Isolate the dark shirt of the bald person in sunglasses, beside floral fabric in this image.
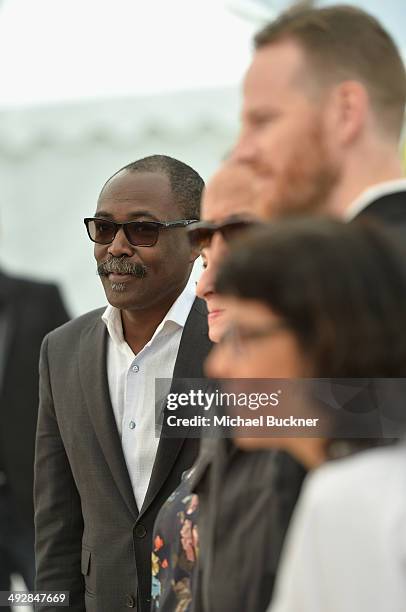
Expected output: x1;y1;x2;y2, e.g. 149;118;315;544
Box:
191;439;306;612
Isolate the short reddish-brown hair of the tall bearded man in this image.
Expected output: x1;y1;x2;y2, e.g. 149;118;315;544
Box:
254;5;406;138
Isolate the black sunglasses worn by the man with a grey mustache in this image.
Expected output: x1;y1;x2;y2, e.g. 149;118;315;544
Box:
84;217;196;247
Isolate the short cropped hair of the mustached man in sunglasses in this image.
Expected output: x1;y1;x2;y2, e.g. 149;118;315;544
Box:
102;155;204;219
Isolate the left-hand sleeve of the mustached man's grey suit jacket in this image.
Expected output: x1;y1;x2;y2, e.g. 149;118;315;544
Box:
34;336;85;612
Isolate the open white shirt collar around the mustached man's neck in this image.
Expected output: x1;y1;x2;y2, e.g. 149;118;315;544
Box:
102;277;196;347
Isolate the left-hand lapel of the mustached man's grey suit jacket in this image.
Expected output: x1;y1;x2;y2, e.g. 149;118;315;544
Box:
79;317;138;517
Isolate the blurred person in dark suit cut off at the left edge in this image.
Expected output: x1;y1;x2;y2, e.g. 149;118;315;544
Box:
0;272;68;591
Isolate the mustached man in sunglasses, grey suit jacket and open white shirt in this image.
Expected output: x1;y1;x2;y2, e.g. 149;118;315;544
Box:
35;156;210;612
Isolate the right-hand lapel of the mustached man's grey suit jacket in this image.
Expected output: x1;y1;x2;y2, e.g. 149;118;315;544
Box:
140;298;211;516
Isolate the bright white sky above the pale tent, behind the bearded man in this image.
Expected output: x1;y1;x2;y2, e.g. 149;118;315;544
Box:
0;0;406;108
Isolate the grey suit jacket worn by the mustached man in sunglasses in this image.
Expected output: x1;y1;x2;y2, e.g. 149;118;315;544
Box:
35;299;211;612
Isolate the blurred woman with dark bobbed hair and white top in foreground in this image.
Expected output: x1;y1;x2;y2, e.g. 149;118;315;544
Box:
207;219;406;612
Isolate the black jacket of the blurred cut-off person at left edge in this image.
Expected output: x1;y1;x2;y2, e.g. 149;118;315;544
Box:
0;272;69;528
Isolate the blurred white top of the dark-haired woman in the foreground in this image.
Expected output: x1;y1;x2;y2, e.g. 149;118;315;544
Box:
268;444;406;612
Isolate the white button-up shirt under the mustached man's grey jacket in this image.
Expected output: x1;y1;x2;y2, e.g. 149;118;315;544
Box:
102;280;196;510
